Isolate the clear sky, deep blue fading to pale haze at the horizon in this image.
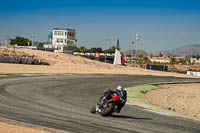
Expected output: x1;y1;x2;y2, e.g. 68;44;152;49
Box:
0;0;200;52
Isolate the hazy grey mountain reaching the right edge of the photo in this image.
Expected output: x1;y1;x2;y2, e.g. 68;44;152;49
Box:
154;44;200;56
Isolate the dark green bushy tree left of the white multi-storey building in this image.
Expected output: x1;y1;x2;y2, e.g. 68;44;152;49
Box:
10;37;30;46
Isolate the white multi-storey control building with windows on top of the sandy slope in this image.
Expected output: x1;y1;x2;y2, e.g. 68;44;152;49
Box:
44;28;77;52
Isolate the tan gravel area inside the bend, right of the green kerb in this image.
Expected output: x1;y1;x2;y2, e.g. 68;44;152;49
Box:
145;83;200;118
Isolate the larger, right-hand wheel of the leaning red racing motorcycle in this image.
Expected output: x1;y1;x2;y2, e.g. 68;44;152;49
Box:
101;102;116;116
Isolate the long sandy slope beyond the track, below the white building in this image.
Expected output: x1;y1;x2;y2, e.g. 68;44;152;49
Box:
0;46;198;77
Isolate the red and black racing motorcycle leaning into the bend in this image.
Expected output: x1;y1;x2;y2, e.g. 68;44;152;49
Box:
91;92;122;116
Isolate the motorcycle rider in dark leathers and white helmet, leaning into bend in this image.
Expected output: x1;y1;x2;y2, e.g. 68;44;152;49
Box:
98;85;127;113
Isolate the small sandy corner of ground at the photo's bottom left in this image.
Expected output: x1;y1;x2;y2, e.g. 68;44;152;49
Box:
0;122;52;133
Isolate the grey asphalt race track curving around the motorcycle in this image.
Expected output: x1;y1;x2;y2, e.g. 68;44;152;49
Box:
0;74;200;133
